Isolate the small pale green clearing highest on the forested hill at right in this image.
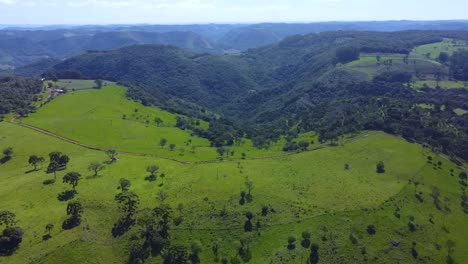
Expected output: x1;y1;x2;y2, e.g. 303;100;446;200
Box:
411;39;468;60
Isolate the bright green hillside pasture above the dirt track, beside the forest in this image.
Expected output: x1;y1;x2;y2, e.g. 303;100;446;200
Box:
21;85;320;161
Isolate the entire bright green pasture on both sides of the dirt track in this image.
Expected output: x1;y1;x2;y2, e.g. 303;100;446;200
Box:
0;81;468;263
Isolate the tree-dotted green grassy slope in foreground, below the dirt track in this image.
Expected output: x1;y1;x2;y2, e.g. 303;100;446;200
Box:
0;118;468;263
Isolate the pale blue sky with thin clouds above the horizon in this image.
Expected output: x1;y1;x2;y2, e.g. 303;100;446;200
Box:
0;0;468;24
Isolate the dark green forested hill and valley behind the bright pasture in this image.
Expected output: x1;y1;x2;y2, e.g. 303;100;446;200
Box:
48;31;468;159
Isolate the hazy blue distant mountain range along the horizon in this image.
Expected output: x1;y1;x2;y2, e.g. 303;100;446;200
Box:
0;20;468;72
